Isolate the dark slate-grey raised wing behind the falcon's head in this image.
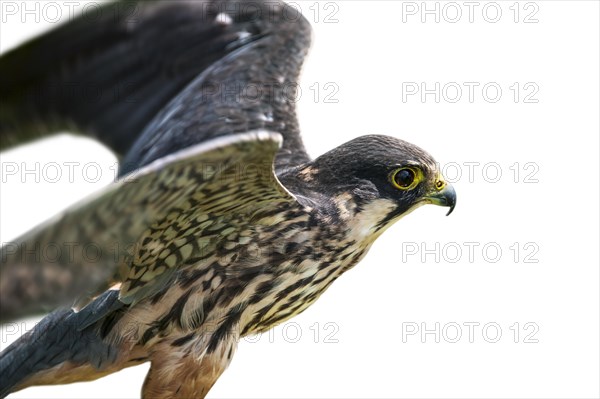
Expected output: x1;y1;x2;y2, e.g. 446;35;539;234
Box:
0;0;310;170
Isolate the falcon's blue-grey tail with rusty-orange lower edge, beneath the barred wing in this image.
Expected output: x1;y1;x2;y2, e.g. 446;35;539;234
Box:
0;309;118;398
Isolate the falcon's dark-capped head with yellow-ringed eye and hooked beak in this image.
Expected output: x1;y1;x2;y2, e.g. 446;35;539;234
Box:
290;135;456;241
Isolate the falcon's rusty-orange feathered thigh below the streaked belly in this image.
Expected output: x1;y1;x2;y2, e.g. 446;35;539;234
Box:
142;329;239;399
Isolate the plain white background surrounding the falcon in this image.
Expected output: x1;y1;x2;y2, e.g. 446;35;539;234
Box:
0;1;600;398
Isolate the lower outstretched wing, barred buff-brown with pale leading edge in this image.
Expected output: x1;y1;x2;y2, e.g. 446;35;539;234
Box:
0;131;295;324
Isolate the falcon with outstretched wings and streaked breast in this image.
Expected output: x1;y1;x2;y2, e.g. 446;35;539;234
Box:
0;0;456;398
